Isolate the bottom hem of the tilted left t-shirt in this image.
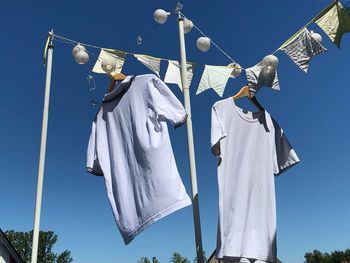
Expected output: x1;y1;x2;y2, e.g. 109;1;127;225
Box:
124;197;191;245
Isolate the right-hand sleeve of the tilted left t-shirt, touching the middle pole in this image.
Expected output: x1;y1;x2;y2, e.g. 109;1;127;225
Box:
151;78;187;128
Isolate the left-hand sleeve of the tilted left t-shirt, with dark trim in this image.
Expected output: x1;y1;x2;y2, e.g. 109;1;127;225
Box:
86;119;103;176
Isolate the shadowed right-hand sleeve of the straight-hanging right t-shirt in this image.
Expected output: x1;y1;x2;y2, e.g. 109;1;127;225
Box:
272;119;300;175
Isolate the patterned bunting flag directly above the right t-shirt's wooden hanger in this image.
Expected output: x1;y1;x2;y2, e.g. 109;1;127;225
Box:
245;62;280;91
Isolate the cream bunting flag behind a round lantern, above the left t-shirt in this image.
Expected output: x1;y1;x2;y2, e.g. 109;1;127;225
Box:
92;49;127;75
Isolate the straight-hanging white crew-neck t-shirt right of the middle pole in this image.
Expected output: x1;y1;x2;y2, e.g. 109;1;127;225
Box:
211;98;299;263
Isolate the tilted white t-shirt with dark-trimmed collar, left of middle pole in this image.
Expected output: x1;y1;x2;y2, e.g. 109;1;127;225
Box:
87;74;191;244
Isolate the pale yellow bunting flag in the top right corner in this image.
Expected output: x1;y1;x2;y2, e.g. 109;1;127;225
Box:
314;1;350;48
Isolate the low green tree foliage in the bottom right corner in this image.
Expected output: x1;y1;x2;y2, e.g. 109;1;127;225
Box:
304;249;350;263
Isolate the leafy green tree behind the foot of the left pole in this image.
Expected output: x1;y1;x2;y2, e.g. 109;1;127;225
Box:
5;230;73;263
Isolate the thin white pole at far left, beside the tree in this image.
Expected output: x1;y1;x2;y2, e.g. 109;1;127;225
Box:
31;30;53;263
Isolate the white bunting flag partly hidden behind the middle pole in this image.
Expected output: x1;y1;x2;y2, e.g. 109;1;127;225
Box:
164;60;196;90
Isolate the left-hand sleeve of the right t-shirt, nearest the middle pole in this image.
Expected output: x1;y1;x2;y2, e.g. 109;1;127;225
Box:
210;105;227;156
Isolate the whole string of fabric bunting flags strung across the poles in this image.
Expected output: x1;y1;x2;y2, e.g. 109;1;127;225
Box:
45;0;350;97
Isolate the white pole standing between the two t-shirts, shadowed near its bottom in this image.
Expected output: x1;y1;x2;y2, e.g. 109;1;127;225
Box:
177;13;203;263
